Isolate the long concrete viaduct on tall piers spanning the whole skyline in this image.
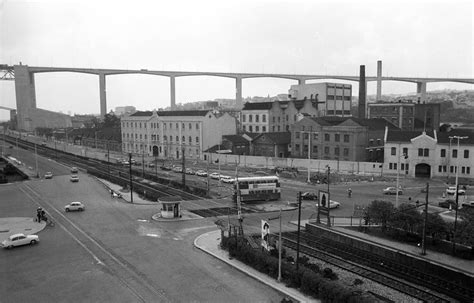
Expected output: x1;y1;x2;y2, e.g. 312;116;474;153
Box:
0;61;474;131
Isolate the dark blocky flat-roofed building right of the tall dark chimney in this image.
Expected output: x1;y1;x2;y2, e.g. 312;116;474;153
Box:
367;102;440;131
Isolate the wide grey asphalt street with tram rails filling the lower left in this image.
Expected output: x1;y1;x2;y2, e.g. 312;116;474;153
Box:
0;144;283;302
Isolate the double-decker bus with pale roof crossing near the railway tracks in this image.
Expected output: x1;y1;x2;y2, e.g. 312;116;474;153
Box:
234;176;281;202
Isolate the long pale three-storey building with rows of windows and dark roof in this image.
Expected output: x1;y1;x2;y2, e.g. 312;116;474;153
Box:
121;110;237;159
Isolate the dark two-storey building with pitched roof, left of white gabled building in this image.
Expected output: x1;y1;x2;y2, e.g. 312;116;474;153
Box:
291;117;396;162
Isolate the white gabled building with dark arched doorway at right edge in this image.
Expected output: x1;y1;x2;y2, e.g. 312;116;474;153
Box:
384;130;474;179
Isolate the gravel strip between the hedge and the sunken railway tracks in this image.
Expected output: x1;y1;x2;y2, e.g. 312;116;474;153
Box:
286;248;423;303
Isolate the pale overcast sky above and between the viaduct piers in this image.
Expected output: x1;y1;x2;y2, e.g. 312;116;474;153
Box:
0;0;474;120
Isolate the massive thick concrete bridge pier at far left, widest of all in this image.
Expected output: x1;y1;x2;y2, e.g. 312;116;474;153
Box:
14;65;36;130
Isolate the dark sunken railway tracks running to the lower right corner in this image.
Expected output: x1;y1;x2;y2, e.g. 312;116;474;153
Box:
284;232;474;302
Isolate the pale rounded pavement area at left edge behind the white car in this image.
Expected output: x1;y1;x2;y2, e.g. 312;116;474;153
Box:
0;217;46;242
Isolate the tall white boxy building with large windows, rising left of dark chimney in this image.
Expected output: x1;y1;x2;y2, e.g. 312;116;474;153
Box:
288;82;352;117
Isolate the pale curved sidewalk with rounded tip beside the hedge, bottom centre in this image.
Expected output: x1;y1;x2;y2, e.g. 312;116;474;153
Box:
194;230;321;302
